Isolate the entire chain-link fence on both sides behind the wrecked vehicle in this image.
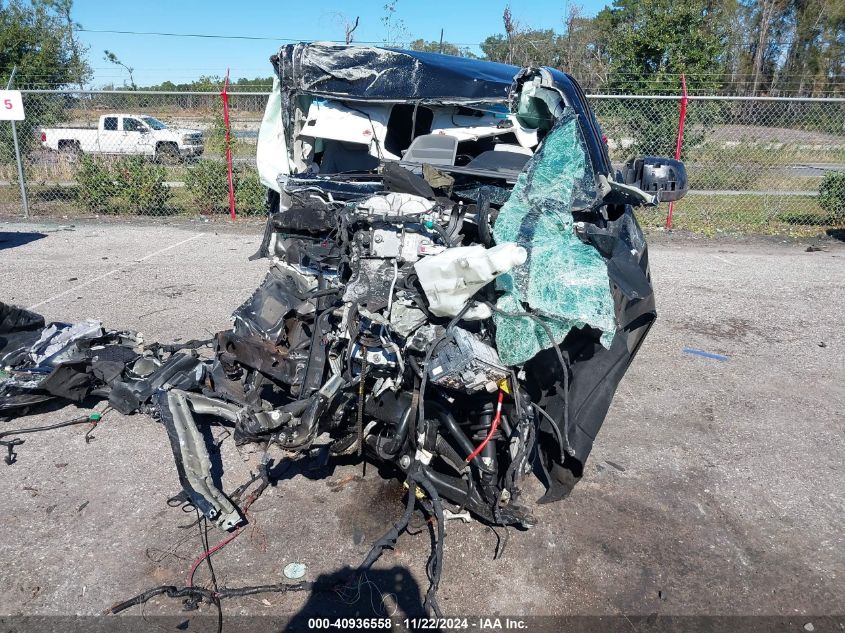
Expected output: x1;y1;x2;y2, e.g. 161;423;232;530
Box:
0;90;845;233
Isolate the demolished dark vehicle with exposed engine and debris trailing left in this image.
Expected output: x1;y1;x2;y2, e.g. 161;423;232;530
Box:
0;44;686;612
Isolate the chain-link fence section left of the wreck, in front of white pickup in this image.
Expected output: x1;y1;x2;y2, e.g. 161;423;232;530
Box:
0;90;267;216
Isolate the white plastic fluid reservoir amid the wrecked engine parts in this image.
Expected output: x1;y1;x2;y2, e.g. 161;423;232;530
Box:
414;242;528;318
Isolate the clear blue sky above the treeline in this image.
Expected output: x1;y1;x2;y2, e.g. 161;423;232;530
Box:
73;0;606;86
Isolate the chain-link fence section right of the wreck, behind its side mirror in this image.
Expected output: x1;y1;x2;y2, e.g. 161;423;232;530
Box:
591;95;845;233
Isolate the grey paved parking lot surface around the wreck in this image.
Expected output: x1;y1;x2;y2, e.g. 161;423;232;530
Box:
0;216;845;631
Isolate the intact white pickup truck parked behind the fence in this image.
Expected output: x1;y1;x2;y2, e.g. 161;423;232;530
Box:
41;114;203;163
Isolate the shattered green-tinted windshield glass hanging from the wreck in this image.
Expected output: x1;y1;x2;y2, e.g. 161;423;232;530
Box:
493;115;616;365
